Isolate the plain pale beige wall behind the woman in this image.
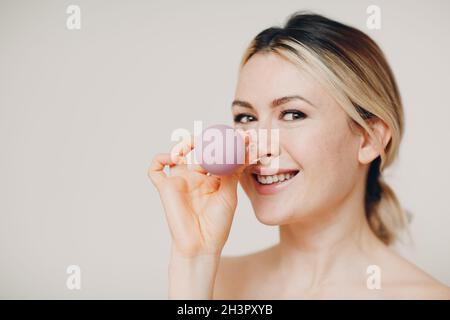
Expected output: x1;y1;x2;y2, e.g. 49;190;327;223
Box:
0;0;450;299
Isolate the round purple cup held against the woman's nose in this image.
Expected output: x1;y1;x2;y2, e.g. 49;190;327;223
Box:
195;124;245;176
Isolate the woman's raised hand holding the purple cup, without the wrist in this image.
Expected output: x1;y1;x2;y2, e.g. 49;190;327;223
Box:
148;136;249;258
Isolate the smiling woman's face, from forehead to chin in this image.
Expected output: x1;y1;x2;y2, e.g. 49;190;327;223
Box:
232;53;361;225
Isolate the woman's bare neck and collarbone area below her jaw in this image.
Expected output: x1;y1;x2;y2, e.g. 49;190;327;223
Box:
277;181;385;290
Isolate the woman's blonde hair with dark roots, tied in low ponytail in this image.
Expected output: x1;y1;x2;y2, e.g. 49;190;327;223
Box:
240;12;407;245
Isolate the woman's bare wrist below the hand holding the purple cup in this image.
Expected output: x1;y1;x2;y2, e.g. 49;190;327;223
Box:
169;246;220;299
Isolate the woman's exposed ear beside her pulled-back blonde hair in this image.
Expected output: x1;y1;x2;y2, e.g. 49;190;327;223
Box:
358;118;392;164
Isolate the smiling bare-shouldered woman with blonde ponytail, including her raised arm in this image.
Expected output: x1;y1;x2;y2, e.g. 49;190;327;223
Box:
149;13;450;299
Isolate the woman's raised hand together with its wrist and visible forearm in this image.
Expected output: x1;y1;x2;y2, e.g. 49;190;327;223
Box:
148;136;249;299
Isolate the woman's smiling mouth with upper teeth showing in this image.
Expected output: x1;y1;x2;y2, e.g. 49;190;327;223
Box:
251;170;300;195
